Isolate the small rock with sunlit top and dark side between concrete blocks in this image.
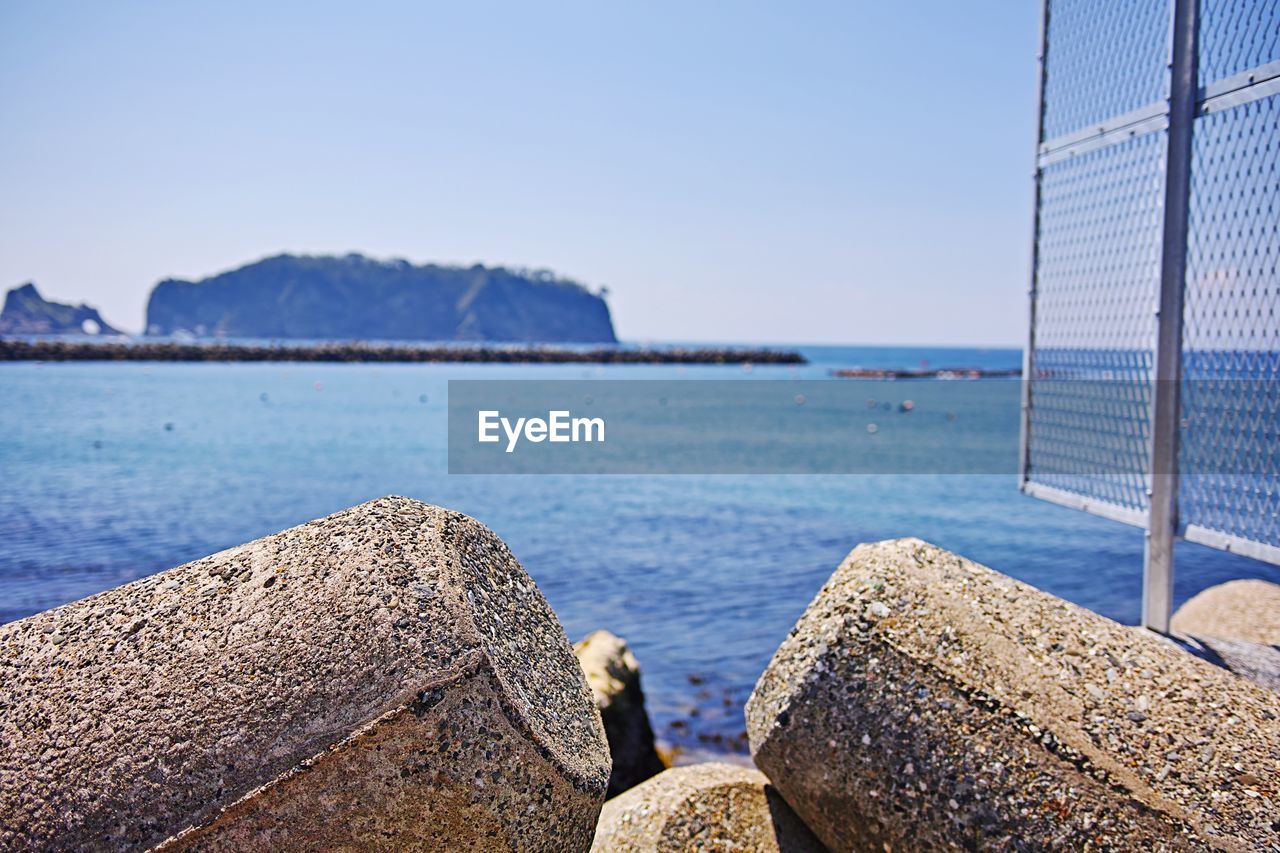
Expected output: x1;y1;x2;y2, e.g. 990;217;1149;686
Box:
573;630;664;797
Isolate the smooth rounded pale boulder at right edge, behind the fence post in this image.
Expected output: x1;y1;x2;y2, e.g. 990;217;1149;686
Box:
1171;580;1280;646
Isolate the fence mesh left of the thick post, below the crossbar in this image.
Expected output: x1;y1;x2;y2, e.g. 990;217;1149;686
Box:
1029;133;1165;510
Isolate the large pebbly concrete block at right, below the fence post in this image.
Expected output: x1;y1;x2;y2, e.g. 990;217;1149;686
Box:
746;539;1280;850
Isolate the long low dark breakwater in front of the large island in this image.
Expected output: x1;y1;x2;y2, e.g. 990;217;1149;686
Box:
0;339;806;365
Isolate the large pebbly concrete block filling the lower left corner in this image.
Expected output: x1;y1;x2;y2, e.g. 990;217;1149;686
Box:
0;497;609;850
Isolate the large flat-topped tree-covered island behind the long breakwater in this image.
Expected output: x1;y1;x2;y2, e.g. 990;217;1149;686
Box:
147;255;617;343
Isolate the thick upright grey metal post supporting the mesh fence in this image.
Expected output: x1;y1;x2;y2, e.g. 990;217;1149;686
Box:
1142;0;1199;634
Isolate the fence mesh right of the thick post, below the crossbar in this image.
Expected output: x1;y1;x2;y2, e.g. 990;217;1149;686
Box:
1179;95;1280;544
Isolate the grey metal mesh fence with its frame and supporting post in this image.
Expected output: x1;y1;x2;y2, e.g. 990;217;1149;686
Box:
1023;0;1280;629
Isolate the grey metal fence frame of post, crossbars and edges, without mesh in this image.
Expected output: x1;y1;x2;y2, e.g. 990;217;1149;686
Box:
1019;0;1280;633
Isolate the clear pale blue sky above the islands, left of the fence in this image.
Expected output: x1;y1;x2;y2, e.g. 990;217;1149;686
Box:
0;0;1037;343
